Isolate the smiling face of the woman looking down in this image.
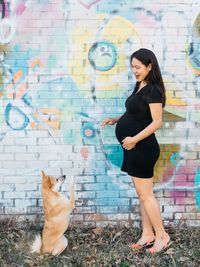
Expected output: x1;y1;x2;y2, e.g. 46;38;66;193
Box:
131;58;151;82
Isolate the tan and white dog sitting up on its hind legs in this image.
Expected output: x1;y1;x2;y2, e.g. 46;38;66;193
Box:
31;171;75;255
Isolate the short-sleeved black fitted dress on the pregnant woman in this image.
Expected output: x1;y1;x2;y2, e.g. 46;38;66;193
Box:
115;84;162;178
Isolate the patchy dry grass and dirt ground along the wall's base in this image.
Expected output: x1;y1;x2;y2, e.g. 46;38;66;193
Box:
0;220;200;267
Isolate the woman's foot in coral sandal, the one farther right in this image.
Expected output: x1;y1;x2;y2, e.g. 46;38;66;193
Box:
147;233;172;254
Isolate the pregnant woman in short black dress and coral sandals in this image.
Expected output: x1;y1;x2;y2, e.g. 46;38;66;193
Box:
101;48;171;254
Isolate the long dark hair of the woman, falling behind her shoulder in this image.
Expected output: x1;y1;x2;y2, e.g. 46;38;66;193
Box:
130;48;166;107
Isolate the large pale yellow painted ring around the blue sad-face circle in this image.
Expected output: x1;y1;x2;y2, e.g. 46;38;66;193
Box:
67;15;141;96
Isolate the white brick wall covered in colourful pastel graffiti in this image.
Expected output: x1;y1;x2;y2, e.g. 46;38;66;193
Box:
0;0;200;225
